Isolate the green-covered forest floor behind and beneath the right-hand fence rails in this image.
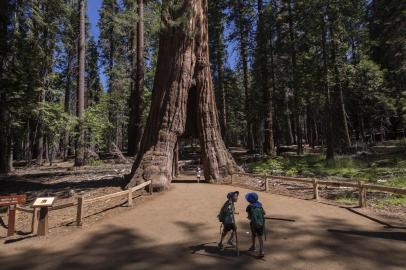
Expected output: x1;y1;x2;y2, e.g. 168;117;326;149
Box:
248;141;406;208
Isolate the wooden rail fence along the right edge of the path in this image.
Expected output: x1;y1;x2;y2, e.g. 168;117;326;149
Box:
231;173;406;207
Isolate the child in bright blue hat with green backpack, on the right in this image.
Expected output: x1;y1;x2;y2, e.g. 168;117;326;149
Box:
245;192;265;258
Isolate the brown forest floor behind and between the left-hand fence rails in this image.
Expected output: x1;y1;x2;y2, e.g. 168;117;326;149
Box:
0;162;136;240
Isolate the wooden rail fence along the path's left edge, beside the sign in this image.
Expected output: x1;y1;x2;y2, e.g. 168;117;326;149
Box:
17;181;152;234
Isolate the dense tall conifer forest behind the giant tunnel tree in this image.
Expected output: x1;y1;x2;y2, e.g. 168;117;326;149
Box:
0;0;406;173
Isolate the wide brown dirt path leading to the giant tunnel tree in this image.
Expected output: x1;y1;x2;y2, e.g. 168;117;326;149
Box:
0;183;406;270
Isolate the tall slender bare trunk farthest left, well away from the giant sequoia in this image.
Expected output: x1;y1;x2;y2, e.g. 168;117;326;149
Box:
75;0;85;166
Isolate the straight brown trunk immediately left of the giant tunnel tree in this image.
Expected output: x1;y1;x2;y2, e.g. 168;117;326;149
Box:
128;0;144;156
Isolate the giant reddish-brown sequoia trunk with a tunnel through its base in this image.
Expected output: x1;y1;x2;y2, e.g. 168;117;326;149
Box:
128;0;239;189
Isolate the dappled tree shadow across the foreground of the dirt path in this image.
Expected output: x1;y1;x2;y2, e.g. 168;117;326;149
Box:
0;214;406;270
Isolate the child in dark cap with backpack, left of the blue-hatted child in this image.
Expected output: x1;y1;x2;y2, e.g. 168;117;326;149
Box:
217;191;240;250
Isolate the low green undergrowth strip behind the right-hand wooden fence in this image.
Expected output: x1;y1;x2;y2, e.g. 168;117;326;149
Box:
250;150;406;187
